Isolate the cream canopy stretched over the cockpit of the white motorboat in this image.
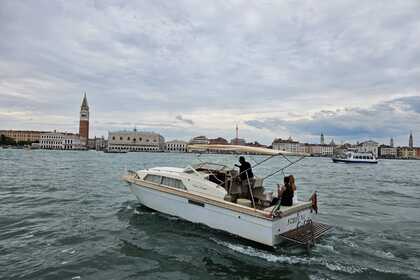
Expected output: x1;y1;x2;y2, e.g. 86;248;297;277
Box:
188;144;310;157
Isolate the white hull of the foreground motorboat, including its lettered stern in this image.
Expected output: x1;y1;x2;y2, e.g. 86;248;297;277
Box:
130;180;313;246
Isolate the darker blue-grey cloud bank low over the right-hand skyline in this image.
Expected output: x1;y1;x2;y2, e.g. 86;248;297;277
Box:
246;96;420;139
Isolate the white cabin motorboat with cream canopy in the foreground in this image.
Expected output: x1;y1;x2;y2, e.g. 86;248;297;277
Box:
123;145;330;248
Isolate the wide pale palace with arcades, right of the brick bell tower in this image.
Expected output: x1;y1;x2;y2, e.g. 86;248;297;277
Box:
107;129;165;152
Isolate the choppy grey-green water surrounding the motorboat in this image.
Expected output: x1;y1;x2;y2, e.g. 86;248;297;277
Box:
0;149;420;279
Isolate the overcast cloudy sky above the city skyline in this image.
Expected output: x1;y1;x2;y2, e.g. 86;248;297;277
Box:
0;0;420;145
